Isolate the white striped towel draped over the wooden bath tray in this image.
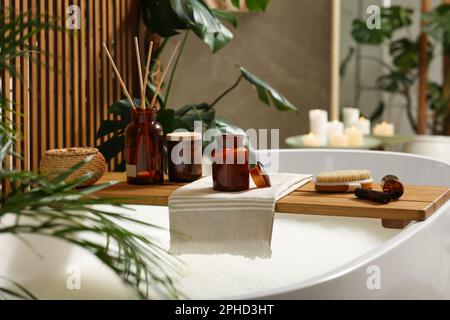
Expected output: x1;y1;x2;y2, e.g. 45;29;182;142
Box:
169;173;312;257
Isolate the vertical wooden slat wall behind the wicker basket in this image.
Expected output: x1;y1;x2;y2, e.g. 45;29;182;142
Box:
0;0;140;171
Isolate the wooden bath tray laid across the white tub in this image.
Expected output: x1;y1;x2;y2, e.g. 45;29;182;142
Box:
96;173;450;229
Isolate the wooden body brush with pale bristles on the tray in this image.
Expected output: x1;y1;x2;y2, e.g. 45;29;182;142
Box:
315;170;374;192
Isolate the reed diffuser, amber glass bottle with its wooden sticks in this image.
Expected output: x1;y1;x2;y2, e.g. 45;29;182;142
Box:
103;37;179;185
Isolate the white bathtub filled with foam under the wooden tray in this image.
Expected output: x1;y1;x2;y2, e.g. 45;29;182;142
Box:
0;150;450;299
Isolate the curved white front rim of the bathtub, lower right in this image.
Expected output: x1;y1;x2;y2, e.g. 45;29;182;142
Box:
232;201;450;300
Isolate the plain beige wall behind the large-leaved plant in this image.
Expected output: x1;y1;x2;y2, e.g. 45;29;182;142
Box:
167;0;330;146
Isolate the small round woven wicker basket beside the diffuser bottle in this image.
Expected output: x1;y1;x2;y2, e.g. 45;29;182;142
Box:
40;148;106;187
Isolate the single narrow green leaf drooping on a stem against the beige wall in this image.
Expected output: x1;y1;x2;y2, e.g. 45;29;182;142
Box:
240;67;298;111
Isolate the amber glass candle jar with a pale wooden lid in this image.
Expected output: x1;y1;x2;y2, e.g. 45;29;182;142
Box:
166;132;203;182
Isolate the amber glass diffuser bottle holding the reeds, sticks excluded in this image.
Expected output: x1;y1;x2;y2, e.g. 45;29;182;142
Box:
125;109;164;185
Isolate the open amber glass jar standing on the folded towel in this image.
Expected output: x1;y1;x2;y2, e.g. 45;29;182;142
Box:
212;134;250;192
